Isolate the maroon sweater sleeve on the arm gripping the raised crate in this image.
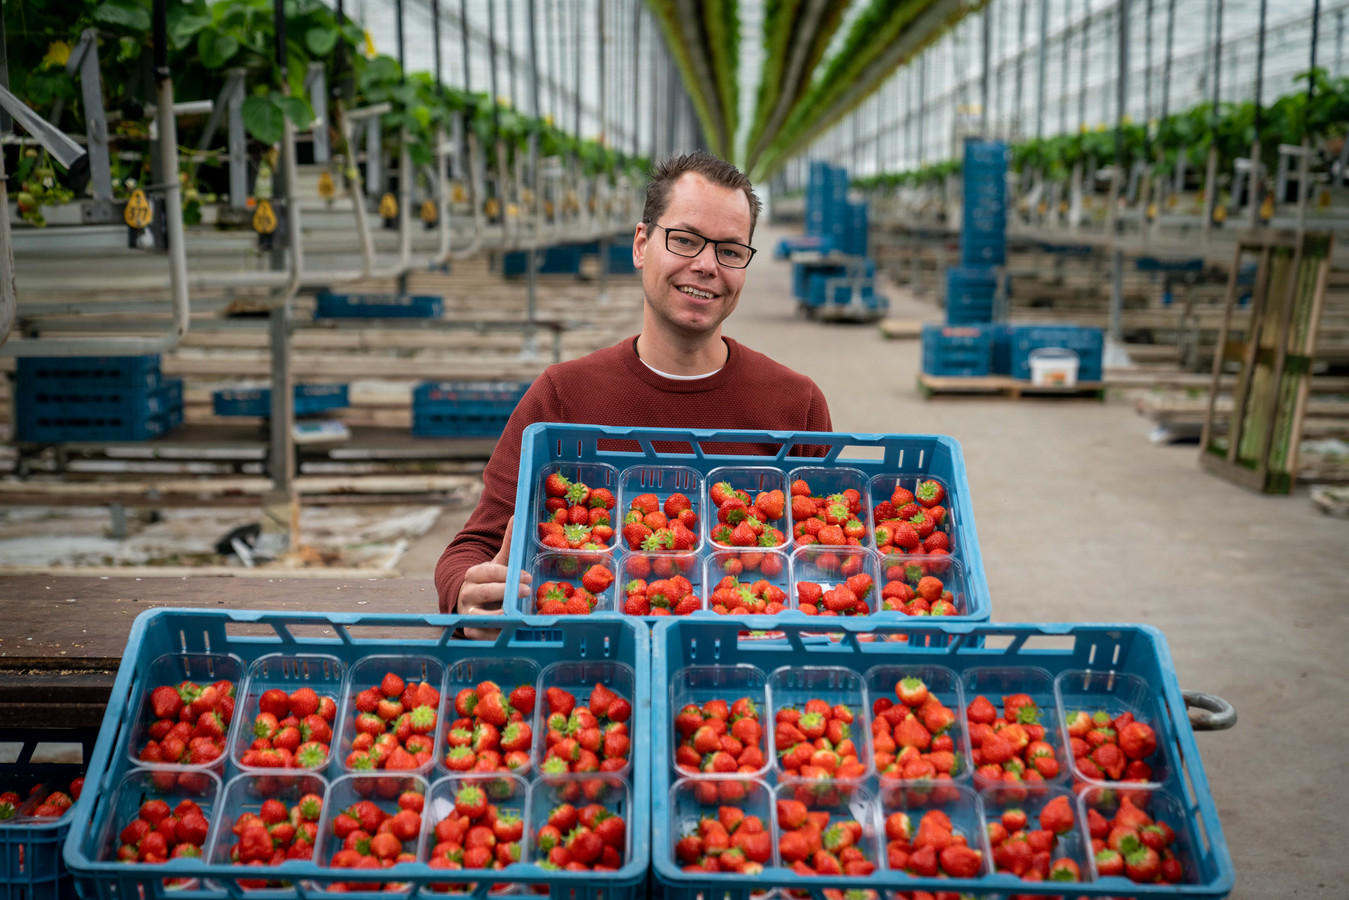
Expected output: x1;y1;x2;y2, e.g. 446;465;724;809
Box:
436;372;563;613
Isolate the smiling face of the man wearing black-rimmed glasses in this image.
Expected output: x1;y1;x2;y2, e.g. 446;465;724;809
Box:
633;173;750;341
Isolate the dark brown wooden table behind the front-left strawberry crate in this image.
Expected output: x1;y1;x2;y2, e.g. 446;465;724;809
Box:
0;576;438;727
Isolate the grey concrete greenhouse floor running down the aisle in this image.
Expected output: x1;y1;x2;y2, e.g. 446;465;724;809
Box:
399;228;1349;900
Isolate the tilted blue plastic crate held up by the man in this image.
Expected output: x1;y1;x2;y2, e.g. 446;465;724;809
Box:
506;422;992;621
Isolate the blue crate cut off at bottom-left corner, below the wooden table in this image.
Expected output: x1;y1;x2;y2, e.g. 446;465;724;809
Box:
0;729;98;900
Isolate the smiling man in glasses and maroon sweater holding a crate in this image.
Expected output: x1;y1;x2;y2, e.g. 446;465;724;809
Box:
436;151;832;614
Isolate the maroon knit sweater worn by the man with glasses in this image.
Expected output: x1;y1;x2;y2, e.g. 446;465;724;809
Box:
436;337;832;613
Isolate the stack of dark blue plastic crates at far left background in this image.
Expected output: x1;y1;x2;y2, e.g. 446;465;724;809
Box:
15;355;182;444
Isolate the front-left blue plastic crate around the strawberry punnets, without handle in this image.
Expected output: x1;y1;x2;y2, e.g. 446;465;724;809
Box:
63;609;652;900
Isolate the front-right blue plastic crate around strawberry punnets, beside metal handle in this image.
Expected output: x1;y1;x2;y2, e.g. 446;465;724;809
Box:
652;618;1234;900
